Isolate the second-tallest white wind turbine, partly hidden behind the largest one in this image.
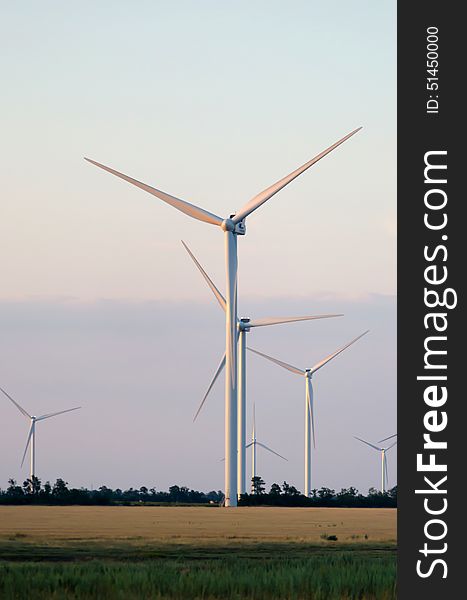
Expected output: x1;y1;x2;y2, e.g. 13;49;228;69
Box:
182;240;342;497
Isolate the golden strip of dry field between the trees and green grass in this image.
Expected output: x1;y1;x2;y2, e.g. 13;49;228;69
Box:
0;506;396;544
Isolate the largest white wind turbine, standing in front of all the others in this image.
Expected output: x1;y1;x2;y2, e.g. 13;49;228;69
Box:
85;127;361;506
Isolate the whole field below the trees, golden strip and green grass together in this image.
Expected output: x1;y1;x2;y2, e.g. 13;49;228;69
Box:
0;506;396;600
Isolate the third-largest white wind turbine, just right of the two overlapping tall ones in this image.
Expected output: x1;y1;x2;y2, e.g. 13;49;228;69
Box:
248;331;368;496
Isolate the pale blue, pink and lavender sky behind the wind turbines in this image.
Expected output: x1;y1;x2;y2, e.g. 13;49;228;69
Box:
0;0;396;490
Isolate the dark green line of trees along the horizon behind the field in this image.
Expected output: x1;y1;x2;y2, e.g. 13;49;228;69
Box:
0;477;397;508
